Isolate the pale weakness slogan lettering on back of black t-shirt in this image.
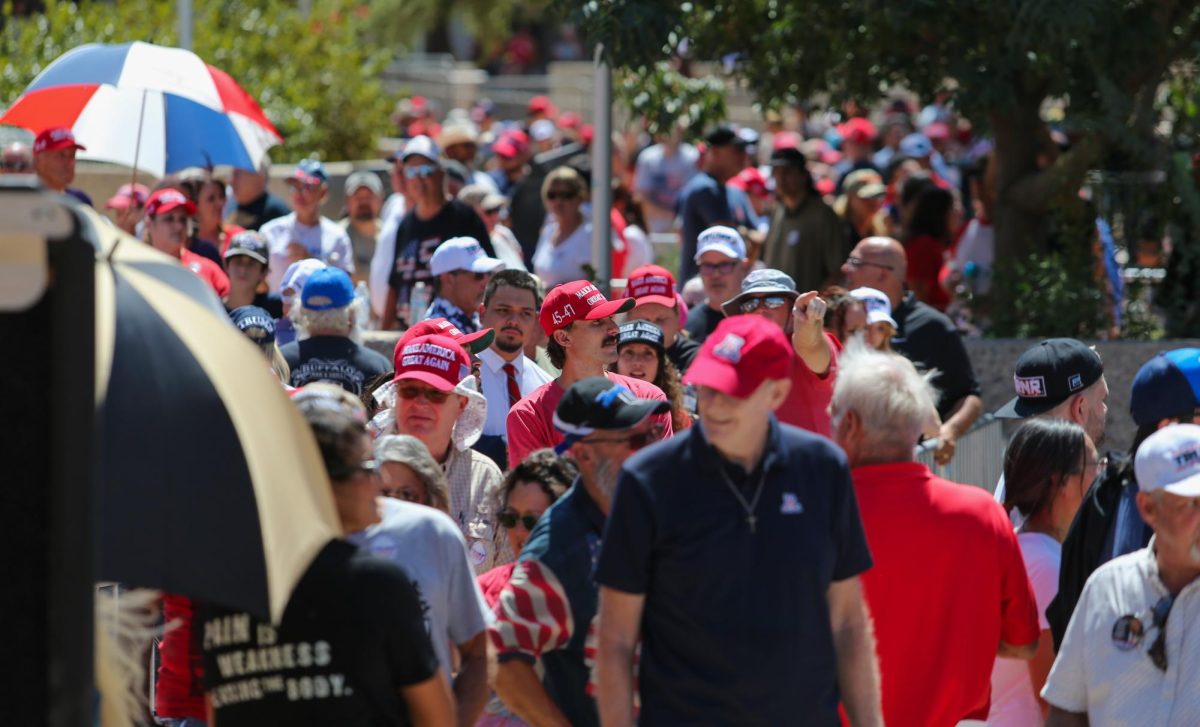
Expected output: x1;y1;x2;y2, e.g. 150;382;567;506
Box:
204;613;354;709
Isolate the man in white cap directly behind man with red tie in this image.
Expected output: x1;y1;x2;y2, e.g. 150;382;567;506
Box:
421;238;504;334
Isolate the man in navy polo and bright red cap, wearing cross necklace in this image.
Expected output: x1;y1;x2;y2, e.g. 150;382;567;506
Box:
596;316;882;726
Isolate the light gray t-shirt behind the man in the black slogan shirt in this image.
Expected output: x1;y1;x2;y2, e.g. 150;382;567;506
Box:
347;498;492;678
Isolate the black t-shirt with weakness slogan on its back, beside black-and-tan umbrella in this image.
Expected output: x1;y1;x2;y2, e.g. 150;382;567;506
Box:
196;540;438;727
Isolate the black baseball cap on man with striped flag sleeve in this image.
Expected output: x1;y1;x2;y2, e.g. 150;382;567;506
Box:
554;377;671;455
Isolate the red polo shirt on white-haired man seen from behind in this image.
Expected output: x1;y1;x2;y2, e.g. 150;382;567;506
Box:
851;462;1039;727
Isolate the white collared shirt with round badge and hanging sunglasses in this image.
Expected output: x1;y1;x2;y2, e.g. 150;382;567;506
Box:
1042;539;1200;727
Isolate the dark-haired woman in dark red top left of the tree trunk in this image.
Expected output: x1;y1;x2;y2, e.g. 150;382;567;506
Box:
901;185;961;311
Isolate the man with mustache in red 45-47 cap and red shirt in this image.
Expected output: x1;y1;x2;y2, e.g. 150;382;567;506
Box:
508;281;674;465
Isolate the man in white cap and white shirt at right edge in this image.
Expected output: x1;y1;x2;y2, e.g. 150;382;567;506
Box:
1042;423;1200;727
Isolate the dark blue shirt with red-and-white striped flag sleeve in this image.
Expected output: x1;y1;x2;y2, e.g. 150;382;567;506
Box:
488;477;605;727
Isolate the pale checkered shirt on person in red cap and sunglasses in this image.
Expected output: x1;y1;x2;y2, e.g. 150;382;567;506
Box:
442;444;515;576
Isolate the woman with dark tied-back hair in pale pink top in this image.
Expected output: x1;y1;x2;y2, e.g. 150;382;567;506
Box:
988;417;1098;727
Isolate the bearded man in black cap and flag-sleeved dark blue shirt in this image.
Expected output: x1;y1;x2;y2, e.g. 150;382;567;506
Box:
488;377;671;727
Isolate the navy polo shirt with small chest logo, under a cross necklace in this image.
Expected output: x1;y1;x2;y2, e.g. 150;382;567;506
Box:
596;416;871;726
